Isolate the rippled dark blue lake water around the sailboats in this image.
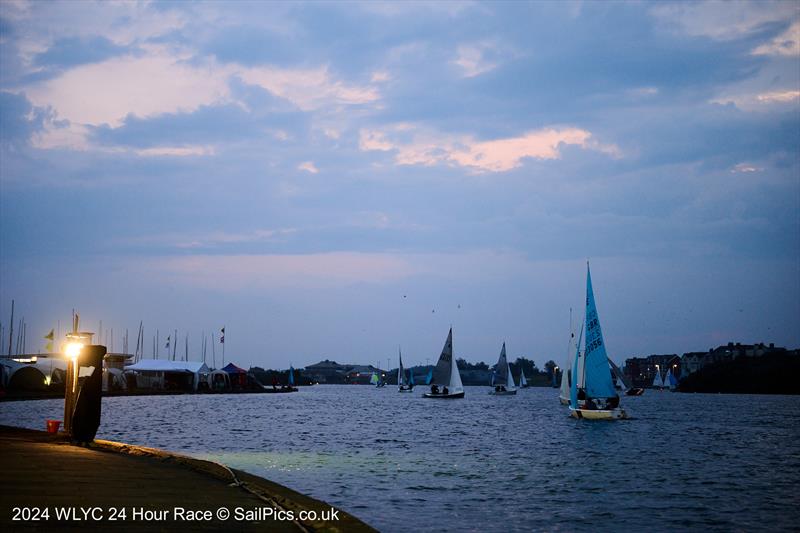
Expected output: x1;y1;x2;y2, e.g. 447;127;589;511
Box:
0;386;800;532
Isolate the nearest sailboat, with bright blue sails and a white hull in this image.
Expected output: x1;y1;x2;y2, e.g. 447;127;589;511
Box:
569;262;628;420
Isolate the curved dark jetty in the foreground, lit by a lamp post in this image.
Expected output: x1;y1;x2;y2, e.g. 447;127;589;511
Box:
0;426;375;532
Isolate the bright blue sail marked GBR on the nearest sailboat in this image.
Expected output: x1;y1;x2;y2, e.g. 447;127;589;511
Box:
584;263;617;398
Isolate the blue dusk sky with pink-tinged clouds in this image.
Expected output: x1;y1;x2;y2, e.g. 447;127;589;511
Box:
0;0;800;368
